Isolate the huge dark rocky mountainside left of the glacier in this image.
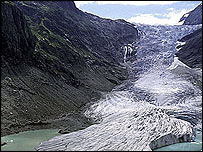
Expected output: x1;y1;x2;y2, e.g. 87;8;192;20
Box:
1;1;138;136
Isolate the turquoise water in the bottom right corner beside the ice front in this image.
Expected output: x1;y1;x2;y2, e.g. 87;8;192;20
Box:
154;132;202;151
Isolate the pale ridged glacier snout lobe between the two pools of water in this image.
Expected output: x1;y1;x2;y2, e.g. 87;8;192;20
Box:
36;102;193;151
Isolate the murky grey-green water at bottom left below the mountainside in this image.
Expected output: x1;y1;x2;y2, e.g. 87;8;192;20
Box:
1;129;61;151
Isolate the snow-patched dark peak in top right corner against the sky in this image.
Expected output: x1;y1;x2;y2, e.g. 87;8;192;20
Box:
179;3;202;25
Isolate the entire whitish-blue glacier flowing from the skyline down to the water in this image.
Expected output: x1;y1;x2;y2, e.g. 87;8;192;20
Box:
36;25;202;151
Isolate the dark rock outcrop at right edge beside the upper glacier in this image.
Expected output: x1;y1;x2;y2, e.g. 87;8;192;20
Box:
176;28;202;68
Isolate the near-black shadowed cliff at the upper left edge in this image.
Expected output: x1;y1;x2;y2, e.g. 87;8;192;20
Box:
1;2;36;65
